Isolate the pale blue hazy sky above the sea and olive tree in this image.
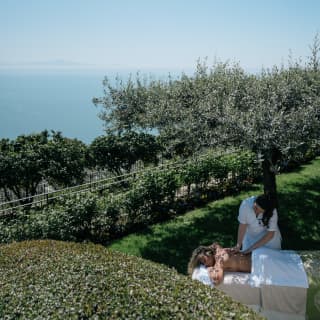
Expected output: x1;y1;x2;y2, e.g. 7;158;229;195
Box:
0;0;320;70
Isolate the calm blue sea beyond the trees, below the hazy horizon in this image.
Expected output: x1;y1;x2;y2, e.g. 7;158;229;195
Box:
0;68;182;144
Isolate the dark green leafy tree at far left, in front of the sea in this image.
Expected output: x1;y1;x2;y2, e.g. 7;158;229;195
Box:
0;131;86;203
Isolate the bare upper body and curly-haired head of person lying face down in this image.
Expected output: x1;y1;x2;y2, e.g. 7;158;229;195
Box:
188;243;251;285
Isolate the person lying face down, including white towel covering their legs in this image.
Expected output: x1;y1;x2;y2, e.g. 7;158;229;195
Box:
188;243;309;288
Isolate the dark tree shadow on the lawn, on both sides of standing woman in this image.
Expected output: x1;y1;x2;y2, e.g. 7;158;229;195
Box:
140;172;320;274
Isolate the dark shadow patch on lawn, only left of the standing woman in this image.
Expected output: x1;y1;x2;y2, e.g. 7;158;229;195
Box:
140;201;239;273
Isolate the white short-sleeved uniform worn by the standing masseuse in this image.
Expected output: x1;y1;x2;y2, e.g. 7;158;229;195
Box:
238;196;281;250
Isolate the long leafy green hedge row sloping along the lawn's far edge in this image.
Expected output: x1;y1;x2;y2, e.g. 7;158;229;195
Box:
0;152;258;243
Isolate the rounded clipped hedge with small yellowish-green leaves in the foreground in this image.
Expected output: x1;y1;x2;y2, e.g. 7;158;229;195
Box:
0;241;260;320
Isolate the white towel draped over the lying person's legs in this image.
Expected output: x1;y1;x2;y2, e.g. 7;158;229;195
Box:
249;248;309;288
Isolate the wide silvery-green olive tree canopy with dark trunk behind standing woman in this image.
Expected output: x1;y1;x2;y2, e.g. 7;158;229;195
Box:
95;43;320;206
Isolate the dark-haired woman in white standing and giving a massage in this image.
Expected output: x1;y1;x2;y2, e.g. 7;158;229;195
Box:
233;195;281;254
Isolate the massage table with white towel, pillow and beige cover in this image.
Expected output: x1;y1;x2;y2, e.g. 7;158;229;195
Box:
192;248;308;320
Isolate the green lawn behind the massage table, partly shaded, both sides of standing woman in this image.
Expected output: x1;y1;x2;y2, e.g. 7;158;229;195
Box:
109;158;320;273
